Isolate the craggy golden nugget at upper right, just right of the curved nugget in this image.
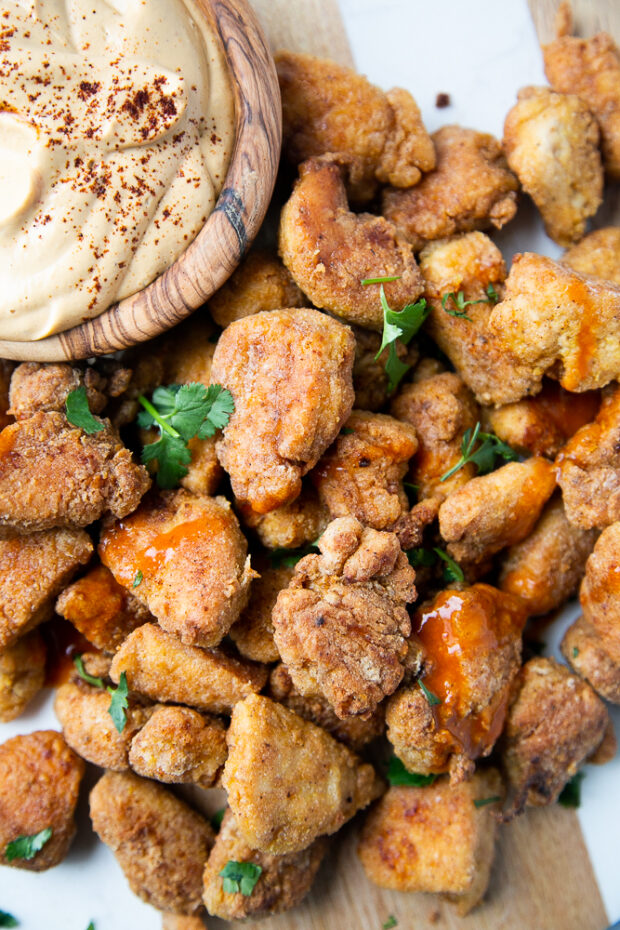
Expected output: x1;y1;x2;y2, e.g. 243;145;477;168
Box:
382;126;519;252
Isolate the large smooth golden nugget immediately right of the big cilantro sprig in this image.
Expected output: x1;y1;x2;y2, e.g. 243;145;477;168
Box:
211;310;355;513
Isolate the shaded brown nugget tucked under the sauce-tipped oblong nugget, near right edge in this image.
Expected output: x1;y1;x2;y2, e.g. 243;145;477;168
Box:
499;497;596;617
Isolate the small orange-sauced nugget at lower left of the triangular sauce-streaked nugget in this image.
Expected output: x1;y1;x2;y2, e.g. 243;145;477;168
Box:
55;565;153;652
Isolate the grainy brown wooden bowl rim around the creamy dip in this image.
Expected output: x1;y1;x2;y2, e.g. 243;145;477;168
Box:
0;0;282;362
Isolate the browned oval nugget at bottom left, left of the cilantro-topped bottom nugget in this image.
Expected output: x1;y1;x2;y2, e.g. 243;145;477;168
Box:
90;772;214;915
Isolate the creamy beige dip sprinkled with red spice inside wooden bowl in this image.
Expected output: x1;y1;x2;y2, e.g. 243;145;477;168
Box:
0;0;234;340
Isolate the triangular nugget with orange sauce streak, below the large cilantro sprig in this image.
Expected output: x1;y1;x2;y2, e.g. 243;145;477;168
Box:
99;490;256;647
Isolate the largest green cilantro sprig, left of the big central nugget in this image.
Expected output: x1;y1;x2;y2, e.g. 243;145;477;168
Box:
138;382;235;488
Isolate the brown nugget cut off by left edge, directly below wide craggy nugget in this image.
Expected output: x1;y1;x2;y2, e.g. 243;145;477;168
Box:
0;529;93;649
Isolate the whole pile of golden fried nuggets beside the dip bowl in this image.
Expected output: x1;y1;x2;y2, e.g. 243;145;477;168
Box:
0;11;620;930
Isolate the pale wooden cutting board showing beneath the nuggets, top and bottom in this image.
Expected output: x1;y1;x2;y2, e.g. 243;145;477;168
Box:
209;0;620;930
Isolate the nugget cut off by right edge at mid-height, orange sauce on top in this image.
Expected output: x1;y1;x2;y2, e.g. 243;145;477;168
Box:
556;385;620;529
